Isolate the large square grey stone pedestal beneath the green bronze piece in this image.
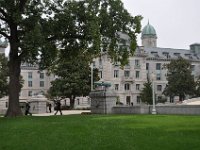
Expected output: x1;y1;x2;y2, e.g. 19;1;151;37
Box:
90;90;117;114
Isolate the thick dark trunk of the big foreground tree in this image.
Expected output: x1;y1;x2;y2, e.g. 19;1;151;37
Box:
5;26;22;117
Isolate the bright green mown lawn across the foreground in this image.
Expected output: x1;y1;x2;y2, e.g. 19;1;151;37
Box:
0;115;200;150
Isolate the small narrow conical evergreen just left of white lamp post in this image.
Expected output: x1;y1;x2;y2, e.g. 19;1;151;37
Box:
140;79;153;105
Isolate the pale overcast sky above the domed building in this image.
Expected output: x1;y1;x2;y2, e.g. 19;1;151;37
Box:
122;0;200;49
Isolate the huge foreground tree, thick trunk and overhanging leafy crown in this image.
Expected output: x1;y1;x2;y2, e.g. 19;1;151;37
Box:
0;0;141;116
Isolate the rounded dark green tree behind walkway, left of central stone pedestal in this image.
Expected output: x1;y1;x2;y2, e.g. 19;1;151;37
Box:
49;55;99;108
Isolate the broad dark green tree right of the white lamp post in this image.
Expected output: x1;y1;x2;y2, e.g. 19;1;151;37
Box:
163;58;195;101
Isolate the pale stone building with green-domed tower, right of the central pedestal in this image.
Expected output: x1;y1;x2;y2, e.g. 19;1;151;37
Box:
94;22;200;105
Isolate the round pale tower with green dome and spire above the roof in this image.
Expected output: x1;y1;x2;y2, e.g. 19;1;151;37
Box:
141;21;157;47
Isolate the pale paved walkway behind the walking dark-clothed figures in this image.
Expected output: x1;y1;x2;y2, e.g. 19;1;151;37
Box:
33;110;91;116
